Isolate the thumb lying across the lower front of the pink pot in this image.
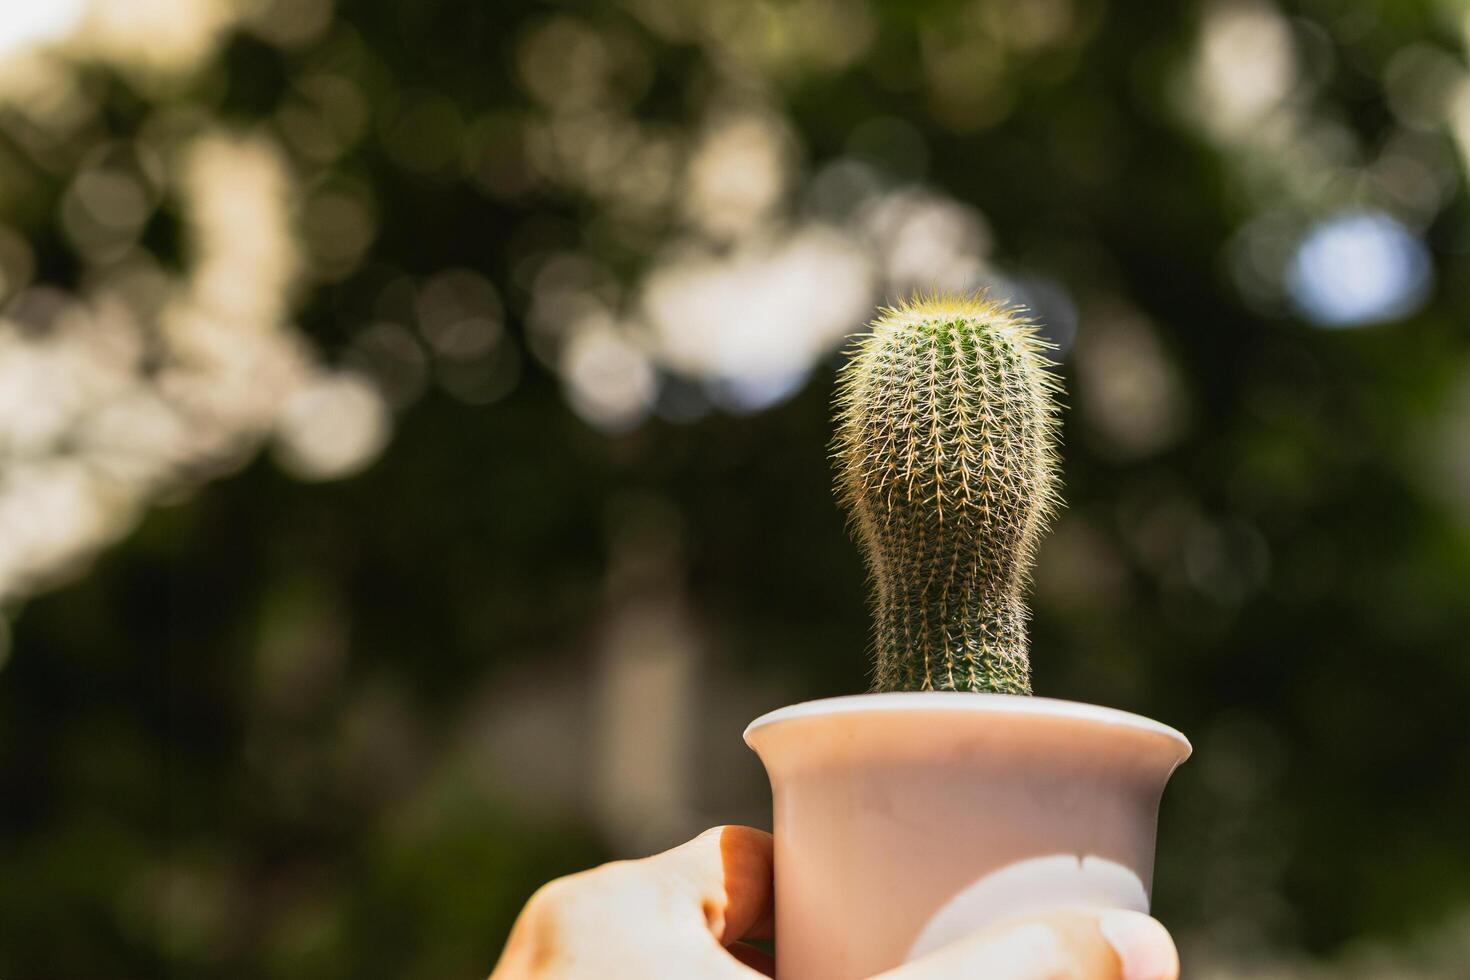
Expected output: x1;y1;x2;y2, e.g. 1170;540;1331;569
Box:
875;909;1179;980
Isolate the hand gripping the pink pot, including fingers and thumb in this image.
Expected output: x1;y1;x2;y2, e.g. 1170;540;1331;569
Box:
491;827;1179;980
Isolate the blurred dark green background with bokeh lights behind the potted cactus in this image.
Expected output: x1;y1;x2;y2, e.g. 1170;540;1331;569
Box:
0;0;1470;980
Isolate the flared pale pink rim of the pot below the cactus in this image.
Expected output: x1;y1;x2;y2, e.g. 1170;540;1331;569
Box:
745;691;1194;763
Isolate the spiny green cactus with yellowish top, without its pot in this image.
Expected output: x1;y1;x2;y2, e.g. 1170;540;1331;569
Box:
833;295;1060;693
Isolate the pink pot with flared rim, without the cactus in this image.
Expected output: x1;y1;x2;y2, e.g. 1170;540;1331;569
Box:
745;692;1189;980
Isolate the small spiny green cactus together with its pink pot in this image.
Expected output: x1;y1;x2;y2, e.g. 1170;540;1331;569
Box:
745;297;1189;980
